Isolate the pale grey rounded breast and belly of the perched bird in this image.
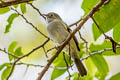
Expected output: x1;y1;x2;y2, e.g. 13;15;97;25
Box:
47;21;68;44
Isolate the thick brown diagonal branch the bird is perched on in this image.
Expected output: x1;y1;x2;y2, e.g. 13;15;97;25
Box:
37;0;106;80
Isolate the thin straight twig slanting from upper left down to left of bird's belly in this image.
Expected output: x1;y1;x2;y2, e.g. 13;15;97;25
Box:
10;7;48;38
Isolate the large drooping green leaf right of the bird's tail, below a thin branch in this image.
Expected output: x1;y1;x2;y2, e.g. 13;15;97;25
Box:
91;54;109;78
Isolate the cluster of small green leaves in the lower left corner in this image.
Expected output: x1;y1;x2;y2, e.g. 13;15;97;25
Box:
0;41;23;80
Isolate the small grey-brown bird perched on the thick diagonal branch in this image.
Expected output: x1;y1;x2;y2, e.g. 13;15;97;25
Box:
43;12;87;76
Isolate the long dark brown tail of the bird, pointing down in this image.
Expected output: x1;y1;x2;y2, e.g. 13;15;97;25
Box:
74;58;87;76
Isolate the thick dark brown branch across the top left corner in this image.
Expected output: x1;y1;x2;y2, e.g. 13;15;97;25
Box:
0;0;34;8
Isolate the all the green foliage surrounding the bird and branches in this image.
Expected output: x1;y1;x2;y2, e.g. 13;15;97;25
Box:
0;0;120;80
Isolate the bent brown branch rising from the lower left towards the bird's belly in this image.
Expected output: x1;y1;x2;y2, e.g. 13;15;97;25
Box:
7;39;49;80
